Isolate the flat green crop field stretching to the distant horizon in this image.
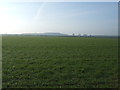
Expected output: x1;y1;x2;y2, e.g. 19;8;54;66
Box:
2;36;118;88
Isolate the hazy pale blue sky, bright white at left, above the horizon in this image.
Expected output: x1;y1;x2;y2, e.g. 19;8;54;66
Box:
0;2;118;35
